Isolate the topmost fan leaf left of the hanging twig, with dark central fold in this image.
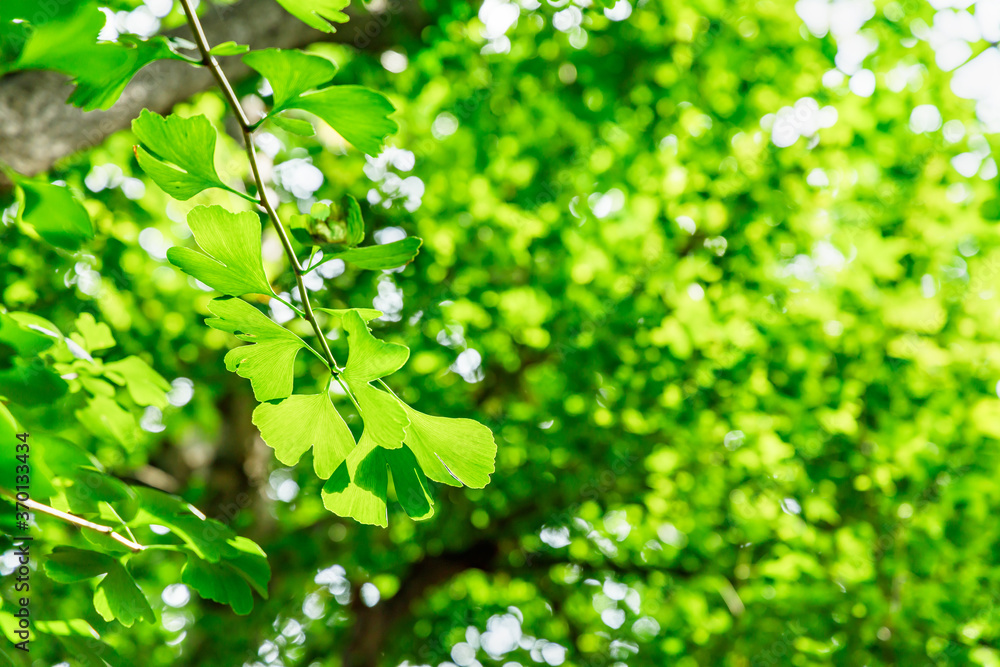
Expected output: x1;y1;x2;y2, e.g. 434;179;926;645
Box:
132;109;247;200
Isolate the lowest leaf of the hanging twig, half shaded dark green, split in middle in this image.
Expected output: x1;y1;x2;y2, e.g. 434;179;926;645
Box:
321;433;434;527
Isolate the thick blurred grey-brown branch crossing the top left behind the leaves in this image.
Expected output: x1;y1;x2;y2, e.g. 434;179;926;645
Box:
0;0;425;183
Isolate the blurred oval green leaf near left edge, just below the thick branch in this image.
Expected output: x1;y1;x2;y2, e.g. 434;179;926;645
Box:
18;181;94;251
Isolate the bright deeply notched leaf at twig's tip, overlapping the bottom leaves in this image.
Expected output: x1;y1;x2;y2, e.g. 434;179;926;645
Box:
343;311;410;449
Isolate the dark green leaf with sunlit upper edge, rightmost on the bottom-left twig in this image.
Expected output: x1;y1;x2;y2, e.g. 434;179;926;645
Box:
181;537;271;615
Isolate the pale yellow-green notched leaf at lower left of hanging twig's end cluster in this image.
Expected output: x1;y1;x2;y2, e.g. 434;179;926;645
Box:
253;392;355;479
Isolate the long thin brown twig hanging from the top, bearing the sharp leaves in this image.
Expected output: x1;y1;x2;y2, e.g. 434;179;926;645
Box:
181;0;341;375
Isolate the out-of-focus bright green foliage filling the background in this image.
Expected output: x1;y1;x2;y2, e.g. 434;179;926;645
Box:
0;0;1000;667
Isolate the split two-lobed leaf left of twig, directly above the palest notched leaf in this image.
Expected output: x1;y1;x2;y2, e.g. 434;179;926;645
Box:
205;297;310;402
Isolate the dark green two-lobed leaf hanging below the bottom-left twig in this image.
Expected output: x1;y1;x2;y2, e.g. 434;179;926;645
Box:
45;547;156;627
